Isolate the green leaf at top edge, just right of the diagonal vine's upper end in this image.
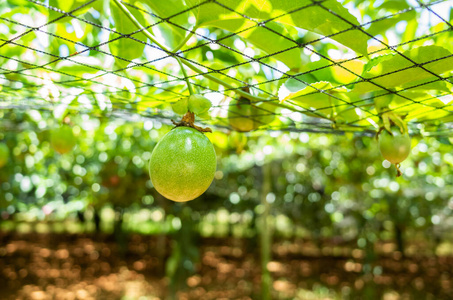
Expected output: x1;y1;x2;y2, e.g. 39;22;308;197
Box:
142;0;190;48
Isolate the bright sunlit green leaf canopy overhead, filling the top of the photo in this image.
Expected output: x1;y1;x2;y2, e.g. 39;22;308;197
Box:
0;0;453;134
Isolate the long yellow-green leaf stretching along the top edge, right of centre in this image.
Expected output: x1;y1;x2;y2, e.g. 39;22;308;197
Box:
186;0;369;55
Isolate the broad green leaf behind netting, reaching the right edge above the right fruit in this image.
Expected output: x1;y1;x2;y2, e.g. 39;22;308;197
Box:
354;45;453;93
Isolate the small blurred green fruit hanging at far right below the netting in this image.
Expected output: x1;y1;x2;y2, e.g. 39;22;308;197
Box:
379;128;411;165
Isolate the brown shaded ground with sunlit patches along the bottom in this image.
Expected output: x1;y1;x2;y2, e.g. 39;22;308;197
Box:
0;233;453;300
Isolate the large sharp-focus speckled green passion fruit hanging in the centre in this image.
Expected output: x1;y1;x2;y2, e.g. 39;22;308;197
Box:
149;126;216;202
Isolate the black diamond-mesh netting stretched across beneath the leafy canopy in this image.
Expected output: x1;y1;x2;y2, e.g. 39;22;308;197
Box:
0;0;453;135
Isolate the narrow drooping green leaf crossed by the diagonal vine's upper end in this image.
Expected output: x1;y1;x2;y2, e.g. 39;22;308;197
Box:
109;3;147;69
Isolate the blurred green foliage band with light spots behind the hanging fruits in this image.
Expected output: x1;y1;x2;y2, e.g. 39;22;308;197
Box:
0;110;453;251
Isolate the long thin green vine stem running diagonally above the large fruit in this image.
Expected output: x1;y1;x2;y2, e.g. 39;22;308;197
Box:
113;0;298;111
